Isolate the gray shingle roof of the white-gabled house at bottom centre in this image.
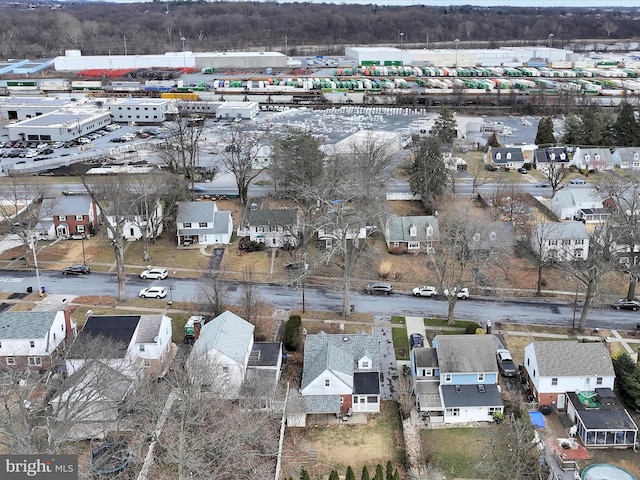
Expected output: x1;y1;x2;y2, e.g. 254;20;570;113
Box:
301;332;380;389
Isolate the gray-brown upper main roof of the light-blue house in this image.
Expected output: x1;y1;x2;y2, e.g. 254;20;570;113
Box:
433;335;498;373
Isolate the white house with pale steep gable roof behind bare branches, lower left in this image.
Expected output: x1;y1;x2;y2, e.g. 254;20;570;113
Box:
187;311;255;398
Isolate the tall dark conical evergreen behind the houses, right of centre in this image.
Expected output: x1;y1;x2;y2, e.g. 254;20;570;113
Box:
409;137;449;214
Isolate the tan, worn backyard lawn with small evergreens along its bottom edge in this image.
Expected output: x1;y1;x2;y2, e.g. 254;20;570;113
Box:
283;402;404;478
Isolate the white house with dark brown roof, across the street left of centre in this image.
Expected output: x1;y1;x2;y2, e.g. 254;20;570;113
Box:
238;208;302;248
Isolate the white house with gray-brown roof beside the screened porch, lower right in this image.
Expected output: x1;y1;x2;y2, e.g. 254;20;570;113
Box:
524;341;615;410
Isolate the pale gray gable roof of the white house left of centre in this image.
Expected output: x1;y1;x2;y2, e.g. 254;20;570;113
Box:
195;310;255;363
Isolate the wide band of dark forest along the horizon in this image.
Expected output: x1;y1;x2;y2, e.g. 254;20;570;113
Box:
0;1;640;59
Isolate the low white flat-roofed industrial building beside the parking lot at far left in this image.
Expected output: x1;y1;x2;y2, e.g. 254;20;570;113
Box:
7;107;111;142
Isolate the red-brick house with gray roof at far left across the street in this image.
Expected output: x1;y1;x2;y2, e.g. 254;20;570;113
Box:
34;195;100;240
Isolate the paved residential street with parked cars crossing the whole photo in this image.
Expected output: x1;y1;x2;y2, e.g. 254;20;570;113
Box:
5;270;640;330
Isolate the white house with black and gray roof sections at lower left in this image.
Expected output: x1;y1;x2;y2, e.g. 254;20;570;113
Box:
66;314;176;380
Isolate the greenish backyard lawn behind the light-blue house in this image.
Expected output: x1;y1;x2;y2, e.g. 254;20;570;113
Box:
420;426;495;478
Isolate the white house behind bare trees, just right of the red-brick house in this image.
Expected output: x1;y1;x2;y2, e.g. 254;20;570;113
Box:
102;199;163;241
